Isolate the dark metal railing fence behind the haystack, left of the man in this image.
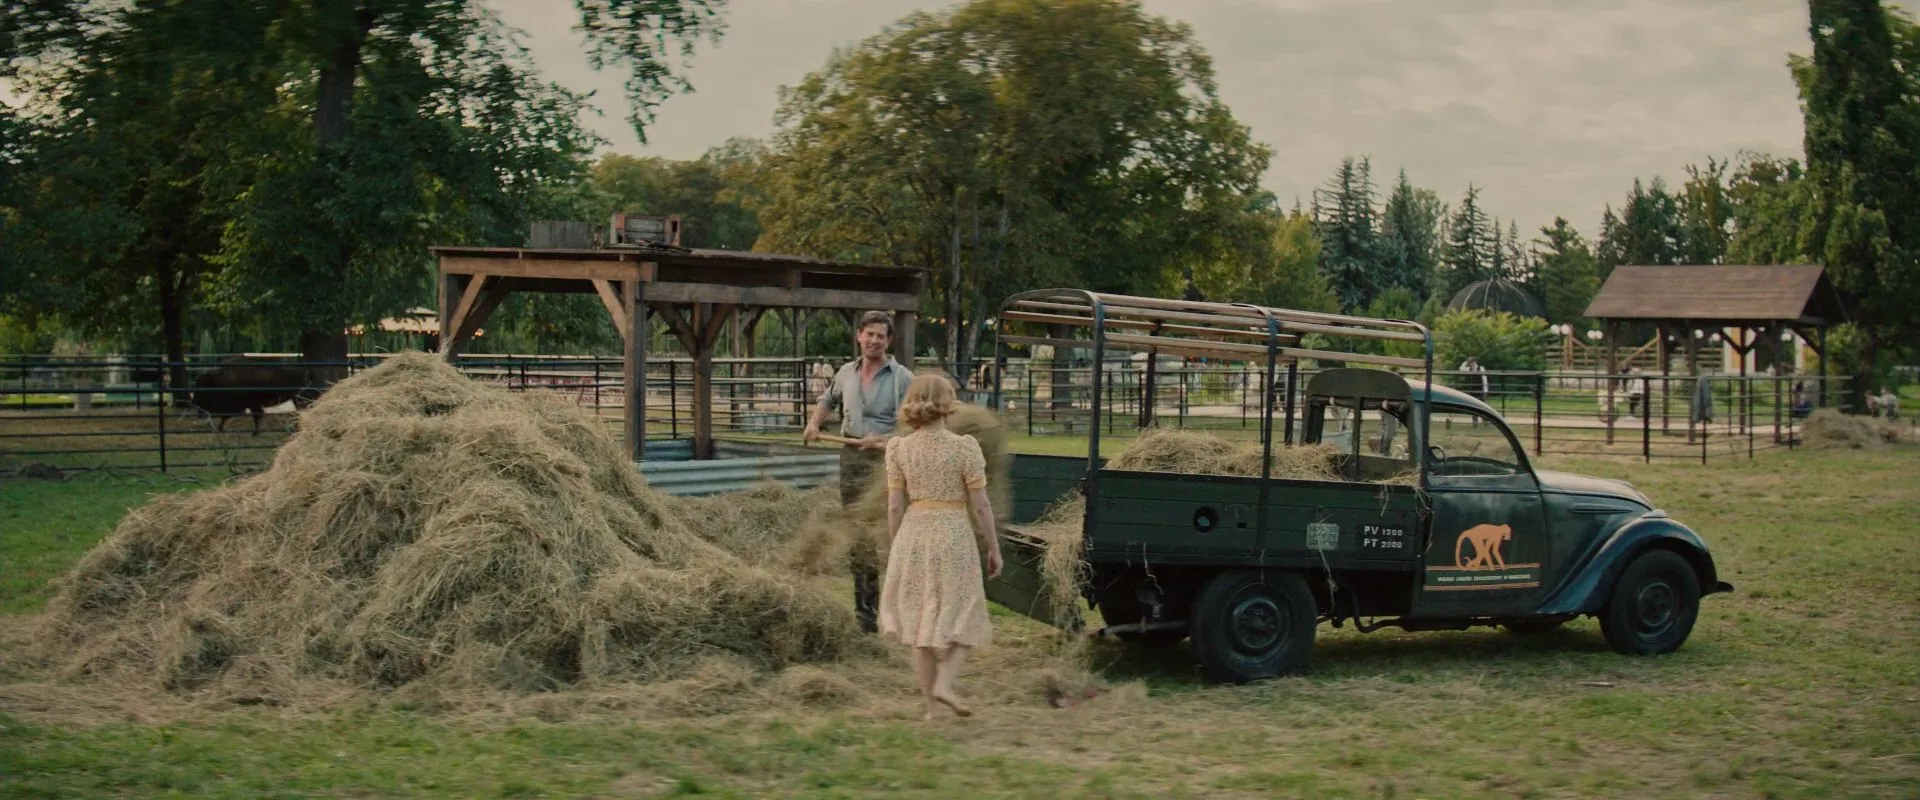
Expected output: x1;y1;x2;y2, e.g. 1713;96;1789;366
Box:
0;355;820;472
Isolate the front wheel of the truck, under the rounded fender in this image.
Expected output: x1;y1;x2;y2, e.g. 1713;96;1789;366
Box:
1599;549;1699;656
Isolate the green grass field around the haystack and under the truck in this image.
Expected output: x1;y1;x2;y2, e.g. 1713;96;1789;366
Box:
0;439;1920;798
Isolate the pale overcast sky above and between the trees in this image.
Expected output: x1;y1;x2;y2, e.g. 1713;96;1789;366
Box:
488;0;1914;243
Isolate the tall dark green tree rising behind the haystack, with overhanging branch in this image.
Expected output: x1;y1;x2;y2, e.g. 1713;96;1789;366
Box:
214;0;718;359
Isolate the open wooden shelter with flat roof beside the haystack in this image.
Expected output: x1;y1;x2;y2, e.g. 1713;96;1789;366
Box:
432;246;925;460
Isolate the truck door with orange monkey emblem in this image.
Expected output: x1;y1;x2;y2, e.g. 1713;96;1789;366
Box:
1413;407;1553;616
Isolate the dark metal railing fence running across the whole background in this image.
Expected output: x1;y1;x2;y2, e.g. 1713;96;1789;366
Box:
0;355;1914;472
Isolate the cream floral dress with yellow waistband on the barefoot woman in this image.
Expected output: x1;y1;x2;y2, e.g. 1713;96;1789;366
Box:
879;430;993;648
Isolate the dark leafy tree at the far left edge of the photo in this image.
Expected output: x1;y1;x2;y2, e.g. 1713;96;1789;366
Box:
0;0;276;384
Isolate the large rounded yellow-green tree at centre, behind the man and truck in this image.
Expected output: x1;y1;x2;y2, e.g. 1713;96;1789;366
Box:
756;0;1269;368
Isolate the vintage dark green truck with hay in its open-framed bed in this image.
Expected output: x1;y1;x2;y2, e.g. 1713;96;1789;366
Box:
987;290;1732;683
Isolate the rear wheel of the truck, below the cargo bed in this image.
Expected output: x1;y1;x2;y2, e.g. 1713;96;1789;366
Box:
1188;570;1319;683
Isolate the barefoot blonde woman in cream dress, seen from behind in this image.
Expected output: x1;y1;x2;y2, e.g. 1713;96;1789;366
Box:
879;372;1000;719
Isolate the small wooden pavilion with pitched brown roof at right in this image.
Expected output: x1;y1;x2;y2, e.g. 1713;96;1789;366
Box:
1586;265;1847;437
